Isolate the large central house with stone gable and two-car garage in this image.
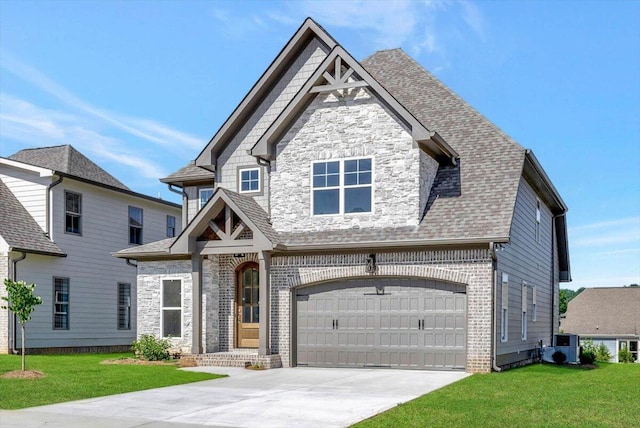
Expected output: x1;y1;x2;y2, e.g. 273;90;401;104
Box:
115;19;570;372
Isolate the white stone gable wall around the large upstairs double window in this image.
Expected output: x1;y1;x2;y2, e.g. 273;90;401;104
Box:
271;89;437;232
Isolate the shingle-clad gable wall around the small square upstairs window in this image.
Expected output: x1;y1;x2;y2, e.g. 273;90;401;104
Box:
216;39;328;212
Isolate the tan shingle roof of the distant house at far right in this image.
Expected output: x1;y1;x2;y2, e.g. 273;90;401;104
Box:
562;287;640;336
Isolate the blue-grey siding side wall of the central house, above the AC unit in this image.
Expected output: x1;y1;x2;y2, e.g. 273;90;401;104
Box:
496;179;558;365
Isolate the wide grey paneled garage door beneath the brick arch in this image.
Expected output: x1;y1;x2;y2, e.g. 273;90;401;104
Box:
294;278;467;370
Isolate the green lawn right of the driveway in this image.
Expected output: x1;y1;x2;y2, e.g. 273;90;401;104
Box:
355;363;640;428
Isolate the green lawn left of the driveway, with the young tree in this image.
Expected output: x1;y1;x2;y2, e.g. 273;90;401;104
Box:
0;354;221;409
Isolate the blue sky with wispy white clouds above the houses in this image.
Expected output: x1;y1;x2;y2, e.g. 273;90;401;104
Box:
0;0;640;289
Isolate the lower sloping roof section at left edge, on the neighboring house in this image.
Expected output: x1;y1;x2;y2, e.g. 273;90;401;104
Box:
0;180;65;257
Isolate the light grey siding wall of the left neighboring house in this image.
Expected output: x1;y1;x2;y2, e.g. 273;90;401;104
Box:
6;178;181;348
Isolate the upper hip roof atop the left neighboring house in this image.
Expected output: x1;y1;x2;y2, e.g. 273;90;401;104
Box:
9;144;130;190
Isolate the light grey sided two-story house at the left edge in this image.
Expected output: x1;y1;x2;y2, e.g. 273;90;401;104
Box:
0;145;181;353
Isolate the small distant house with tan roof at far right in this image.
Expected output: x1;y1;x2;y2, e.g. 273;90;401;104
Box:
560;287;640;362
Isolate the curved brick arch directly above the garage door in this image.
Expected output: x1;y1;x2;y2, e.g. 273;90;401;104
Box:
289;265;471;287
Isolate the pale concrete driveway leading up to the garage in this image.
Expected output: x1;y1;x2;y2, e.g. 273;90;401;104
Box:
0;367;468;428
